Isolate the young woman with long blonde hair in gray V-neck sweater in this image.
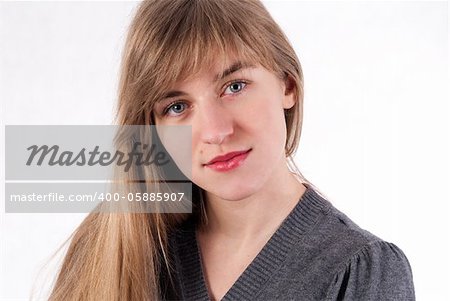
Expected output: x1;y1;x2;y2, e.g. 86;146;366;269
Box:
50;0;415;300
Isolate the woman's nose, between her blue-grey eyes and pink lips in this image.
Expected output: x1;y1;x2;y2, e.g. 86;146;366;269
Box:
197;100;234;144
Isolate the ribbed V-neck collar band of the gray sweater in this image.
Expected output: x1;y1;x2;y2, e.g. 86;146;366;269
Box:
171;183;330;301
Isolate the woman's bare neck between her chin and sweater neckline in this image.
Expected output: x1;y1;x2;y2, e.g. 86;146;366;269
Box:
200;158;306;248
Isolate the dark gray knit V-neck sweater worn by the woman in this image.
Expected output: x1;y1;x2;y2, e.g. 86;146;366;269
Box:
162;184;415;300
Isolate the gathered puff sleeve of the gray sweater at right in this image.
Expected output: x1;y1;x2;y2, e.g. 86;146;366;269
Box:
327;241;415;301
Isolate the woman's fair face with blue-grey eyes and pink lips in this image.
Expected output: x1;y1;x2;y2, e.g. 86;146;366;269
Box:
154;59;295;200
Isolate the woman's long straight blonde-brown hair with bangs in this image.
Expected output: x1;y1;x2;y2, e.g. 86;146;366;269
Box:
49;0;326;301
